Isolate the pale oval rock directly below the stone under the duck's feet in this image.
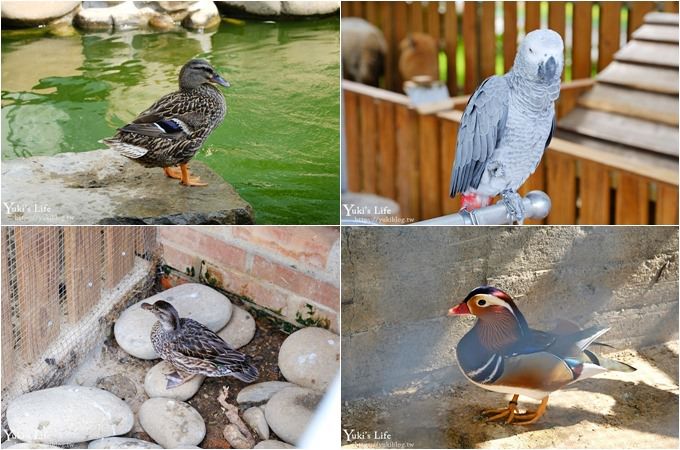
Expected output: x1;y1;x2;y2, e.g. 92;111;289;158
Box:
139;397;205;448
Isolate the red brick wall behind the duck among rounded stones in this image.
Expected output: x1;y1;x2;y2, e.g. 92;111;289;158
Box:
159;226;340;332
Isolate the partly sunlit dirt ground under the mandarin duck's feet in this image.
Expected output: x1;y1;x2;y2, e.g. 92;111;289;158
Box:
342;341;678;448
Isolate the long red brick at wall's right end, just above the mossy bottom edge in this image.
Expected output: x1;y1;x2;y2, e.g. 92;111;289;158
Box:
250;255;340;311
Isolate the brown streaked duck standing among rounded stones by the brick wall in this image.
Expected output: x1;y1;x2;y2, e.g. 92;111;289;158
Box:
142;300;258;389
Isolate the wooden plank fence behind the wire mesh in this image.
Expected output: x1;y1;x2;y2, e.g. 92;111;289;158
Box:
1;227;155;389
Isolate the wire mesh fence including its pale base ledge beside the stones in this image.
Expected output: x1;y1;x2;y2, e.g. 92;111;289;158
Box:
0;226;158;422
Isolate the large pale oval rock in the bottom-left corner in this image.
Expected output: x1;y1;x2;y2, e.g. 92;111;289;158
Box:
7;386;134;445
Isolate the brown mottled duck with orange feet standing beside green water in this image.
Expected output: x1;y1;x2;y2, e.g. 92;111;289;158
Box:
102;59;229;186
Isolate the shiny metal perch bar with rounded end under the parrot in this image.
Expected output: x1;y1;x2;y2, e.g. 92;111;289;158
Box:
411;191;551;225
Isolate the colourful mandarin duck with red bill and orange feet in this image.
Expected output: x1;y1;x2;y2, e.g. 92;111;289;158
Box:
448;286;635;425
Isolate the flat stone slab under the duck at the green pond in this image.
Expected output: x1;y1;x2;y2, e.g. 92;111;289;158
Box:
1;150;254;225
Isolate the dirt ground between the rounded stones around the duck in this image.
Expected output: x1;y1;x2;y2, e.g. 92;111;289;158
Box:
70;299;288;448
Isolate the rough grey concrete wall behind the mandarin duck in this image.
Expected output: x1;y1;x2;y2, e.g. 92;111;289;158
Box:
342;227;678;399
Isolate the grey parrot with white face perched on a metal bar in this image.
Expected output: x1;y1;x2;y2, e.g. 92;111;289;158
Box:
450;30;564;223
